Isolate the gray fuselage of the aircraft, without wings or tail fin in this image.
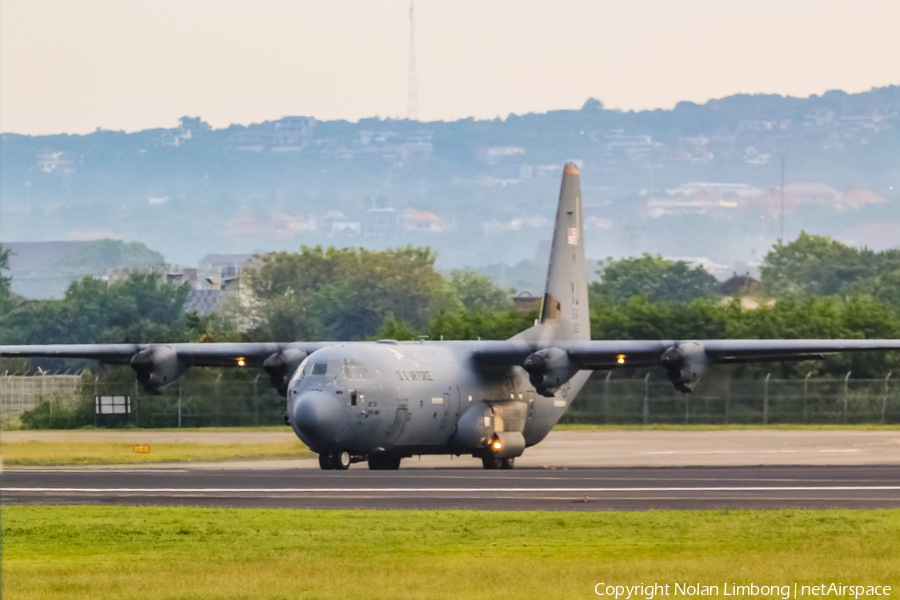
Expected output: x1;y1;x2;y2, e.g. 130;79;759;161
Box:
287;341;589;456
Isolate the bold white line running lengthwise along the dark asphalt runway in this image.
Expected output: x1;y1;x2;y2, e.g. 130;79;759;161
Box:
0;485;900;494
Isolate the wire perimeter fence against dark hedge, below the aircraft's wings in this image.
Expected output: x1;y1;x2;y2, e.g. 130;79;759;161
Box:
0;372;900;429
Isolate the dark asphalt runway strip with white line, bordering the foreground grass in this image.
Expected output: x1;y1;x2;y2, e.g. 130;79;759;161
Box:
7;465;900;511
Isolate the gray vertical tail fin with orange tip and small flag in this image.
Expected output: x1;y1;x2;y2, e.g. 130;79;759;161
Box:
516;162;591;342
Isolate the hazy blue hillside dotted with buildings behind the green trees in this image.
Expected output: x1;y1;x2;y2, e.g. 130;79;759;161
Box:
0;86;900;272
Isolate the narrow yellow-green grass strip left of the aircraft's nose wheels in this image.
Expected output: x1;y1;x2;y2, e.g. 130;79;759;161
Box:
0;440;315;466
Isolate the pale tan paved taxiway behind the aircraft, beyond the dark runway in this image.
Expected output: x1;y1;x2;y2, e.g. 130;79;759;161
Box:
3;427;900;470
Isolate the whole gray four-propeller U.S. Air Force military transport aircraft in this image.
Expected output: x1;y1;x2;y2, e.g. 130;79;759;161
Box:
0;162;900;470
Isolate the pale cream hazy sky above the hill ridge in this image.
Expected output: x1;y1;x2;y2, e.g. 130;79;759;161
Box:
0;0;900;134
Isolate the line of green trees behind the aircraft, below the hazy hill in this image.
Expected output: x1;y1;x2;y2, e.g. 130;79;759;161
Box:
0;233;900;377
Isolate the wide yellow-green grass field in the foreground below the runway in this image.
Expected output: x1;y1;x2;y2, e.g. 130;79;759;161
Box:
2;506;900;600
